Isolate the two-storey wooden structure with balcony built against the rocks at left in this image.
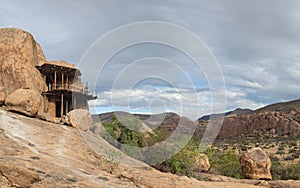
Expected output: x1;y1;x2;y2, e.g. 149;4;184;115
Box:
37;61;97;118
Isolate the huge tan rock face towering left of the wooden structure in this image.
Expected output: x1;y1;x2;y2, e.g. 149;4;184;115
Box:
0;28;46;103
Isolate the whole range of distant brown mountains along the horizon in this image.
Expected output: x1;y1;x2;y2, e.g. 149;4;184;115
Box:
93;100;300;139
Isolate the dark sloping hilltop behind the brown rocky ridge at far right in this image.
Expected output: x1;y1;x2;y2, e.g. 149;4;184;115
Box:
253;99;300;113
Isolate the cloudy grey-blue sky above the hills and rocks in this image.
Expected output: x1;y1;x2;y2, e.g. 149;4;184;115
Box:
0;0;300;119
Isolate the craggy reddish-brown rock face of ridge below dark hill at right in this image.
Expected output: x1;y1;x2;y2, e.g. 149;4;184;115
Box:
195;111;300;140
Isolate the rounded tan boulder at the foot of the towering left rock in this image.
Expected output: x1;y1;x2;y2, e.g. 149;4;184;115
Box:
5;89;43;117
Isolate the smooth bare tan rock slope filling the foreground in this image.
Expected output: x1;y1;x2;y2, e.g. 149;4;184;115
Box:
0;109;282;188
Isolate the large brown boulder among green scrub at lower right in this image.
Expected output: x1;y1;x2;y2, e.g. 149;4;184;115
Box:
240;148;272;180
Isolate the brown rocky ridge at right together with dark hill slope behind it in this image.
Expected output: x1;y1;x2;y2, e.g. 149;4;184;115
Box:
195;100;300;139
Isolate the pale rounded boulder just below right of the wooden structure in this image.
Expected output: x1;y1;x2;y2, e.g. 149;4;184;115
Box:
66;109;93;131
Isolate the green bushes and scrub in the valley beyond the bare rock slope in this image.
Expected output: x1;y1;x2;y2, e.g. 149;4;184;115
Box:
101;116;300;180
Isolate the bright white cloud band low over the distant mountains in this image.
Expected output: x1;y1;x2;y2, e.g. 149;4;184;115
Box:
89;86;263;119
